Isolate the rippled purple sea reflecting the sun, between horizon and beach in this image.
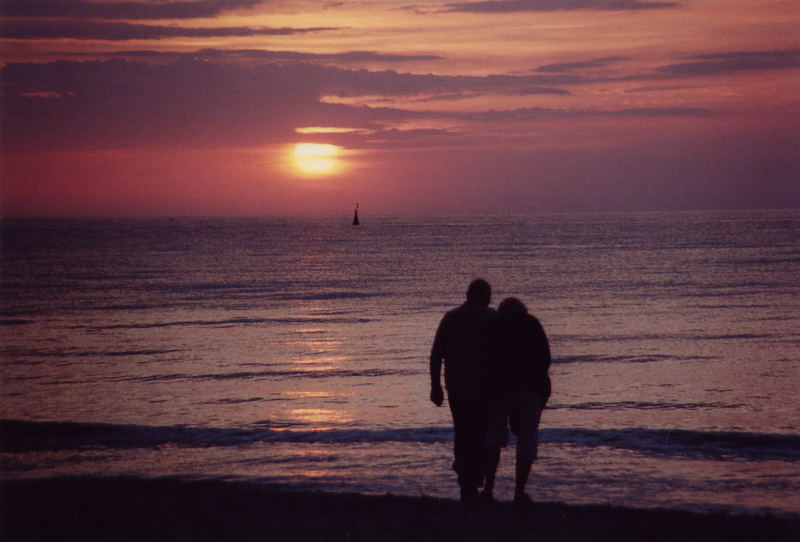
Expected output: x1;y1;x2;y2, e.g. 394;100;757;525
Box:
0;210;800;515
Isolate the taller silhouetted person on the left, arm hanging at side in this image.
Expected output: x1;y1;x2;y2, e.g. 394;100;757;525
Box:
430;279;494;502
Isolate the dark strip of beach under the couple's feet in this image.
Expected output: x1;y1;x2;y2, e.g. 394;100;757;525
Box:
0;478;800;542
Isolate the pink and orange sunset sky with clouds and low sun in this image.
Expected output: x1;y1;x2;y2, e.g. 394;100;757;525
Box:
0;0;800;216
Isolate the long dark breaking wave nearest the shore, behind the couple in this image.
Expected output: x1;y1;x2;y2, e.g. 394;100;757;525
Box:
0;420;800;462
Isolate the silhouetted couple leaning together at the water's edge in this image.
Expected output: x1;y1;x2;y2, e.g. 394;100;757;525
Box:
430;279;550;504
